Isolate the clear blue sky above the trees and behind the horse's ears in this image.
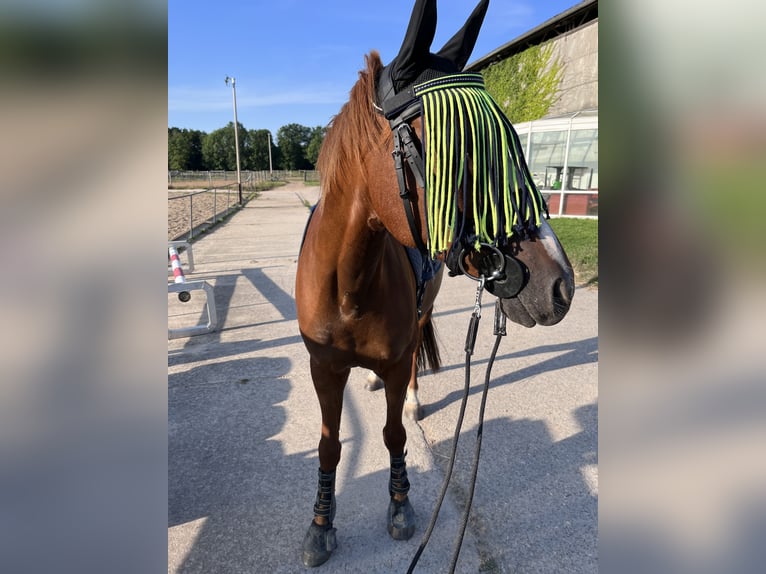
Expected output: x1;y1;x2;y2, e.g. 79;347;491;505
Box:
168;0;578;135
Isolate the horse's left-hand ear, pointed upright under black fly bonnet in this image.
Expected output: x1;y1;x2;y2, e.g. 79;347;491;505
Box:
392;0;436;90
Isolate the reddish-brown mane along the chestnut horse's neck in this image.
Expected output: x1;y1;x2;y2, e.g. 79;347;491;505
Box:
317;50;390;194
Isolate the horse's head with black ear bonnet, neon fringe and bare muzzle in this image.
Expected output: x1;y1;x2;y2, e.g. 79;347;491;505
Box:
369;0;574;327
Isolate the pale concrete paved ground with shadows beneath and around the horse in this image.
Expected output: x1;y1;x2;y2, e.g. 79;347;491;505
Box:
168;184;598;574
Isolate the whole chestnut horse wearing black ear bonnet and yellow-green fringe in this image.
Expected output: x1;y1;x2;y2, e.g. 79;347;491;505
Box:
295;0;574;566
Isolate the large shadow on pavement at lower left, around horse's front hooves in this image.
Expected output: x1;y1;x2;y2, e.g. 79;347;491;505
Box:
168;357;462;573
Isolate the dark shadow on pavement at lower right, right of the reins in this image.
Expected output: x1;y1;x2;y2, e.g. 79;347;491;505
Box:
434;404;598;573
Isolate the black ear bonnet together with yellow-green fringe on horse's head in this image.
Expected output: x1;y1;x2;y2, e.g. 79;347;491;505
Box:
376;0;546;278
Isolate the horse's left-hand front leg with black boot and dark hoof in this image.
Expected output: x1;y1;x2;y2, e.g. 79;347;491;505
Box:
303;359;350;566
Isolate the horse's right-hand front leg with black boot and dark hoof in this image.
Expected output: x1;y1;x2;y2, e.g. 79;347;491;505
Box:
383;361;415;540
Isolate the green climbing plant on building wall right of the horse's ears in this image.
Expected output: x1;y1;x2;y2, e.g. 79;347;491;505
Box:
482;42;563;123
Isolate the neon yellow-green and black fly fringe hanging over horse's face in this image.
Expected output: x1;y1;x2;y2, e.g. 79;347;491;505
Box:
414;73;547;256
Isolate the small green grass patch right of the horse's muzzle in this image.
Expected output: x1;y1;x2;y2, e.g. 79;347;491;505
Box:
548;217;598;287
